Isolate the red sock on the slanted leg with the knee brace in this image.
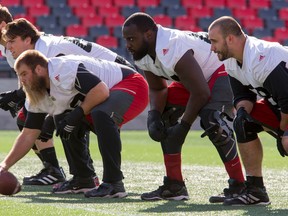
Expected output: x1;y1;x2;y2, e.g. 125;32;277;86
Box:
224;156;245;182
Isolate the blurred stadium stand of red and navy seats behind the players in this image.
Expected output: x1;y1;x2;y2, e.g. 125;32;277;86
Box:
0;0;288;77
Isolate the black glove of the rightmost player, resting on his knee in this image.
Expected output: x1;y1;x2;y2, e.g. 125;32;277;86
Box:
233;107;254;139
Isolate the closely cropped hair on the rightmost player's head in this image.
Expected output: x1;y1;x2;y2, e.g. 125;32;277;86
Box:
209;16;243;38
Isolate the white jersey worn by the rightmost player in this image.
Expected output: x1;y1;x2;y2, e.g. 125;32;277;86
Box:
224;36;288;88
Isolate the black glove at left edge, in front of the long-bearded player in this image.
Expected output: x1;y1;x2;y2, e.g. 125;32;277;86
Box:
0;88;26;117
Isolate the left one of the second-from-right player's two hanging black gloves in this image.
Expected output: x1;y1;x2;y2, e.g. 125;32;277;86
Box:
147;110;166;142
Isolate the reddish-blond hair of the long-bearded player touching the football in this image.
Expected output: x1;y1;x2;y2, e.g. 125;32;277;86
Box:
14;50;48;72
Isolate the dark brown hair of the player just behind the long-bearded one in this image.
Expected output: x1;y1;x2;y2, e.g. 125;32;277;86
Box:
3;18;41;44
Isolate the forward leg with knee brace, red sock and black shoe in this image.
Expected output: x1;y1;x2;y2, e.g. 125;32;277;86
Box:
200;109;245;203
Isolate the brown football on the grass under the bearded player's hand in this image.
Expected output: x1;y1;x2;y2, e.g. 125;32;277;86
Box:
0;171;21;195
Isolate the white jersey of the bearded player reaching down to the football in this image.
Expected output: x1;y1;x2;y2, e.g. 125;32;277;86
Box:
25;55;123;115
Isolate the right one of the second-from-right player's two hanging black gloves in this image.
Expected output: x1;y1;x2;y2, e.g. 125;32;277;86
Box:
165;120;191;146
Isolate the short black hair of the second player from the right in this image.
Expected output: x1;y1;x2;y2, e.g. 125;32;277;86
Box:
123;12;157;32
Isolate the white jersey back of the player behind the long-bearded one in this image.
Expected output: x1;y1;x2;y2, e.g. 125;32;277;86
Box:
35;34;117;61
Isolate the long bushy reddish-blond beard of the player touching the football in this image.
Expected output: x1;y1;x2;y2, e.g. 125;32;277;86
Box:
23;73;47;106
